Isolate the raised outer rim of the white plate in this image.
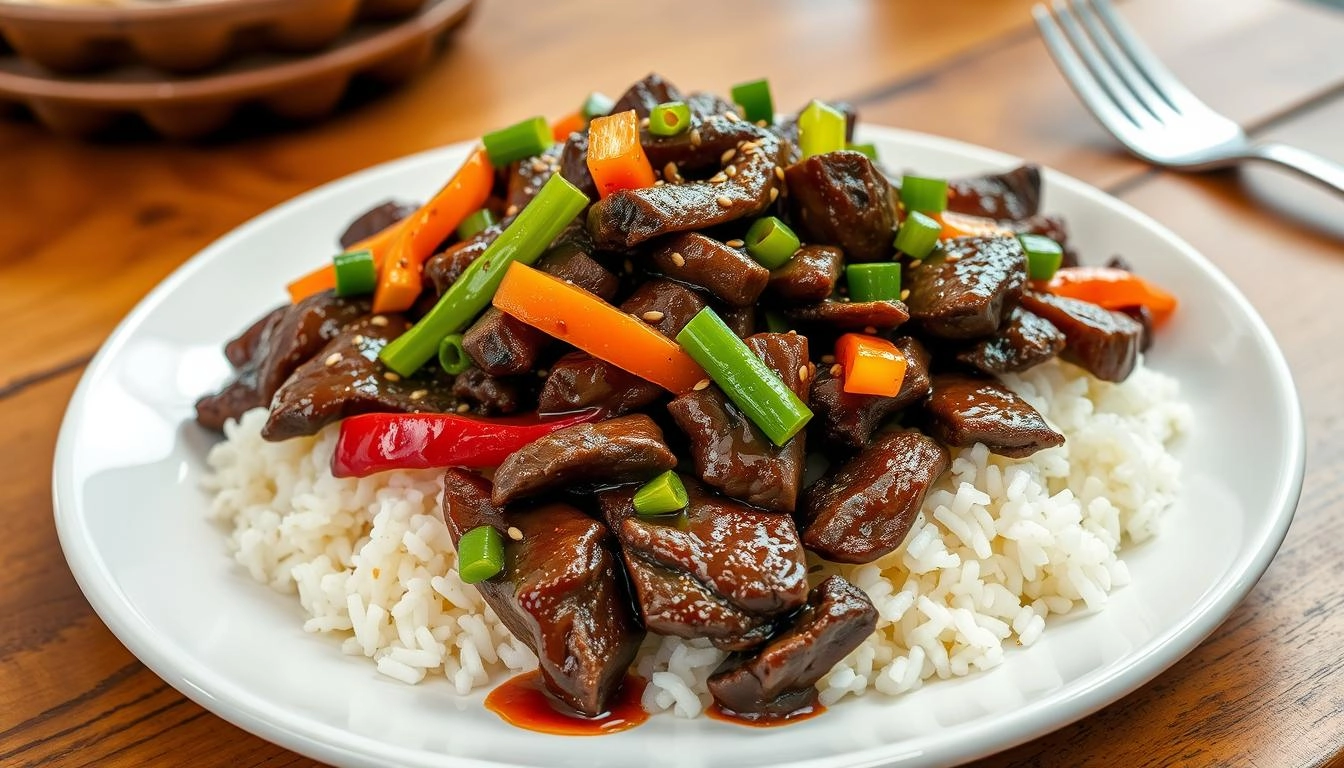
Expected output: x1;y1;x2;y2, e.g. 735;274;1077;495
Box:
52;124;1306;768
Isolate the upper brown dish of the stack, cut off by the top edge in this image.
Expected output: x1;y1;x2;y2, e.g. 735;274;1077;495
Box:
0;0;425;73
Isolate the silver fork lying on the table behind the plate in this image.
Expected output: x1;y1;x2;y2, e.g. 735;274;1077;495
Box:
1032;0;1344;192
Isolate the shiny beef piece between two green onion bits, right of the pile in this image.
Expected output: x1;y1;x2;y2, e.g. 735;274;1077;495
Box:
905;237;1027;339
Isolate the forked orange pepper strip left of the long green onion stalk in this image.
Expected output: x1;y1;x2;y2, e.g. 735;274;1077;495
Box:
288;147;495;312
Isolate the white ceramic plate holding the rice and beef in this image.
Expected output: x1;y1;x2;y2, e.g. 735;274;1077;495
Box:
55;128;1304;768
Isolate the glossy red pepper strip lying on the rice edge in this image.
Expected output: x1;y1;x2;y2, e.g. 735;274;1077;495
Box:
332;409;602;477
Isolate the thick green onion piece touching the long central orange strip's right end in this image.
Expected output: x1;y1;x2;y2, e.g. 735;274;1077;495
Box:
676;307;812;445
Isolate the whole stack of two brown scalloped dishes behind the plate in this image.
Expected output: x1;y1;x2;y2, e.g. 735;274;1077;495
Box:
0;0;474;139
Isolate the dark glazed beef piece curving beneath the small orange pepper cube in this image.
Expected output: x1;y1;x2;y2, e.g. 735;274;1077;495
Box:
808;336;930;451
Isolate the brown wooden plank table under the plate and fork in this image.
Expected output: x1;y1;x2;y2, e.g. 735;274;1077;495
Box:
0;0;1344;768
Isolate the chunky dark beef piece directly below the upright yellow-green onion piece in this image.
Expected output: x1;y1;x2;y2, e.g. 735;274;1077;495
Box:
784;151;896;261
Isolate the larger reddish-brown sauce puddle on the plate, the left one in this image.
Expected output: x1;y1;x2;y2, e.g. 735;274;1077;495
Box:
485;671;649;736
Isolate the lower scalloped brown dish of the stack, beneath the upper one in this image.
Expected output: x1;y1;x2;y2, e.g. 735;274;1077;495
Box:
0;0;474;139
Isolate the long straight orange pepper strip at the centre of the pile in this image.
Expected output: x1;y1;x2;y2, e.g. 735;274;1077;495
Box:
495;262;707;394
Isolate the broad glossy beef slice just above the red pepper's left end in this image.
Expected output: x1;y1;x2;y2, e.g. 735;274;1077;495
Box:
261;315;458;441
